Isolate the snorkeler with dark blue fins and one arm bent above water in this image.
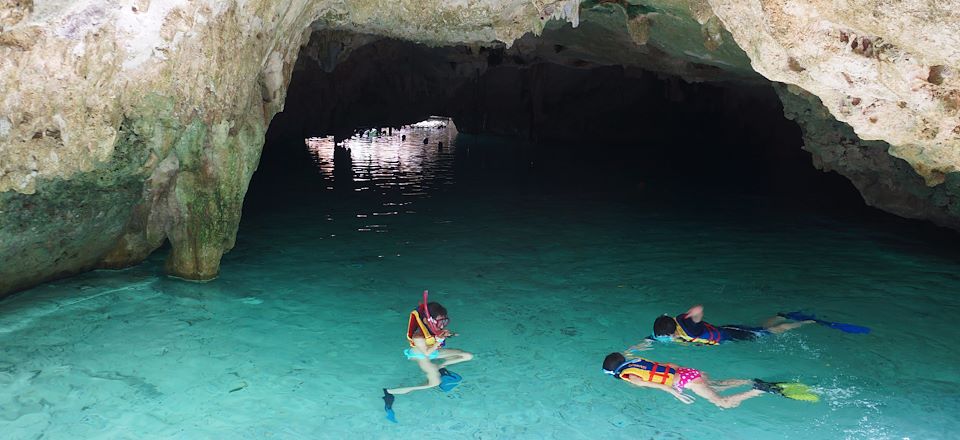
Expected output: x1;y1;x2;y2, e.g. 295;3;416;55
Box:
651;305;815;345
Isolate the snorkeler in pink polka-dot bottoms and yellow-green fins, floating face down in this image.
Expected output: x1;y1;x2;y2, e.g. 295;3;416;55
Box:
603;353;820;408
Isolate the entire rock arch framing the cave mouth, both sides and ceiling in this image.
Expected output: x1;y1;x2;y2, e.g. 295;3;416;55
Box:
0;0;960;294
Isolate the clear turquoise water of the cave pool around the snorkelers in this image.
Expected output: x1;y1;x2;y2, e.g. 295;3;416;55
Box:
0;123;960;439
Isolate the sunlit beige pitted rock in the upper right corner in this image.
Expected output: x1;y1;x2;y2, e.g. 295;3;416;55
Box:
709;0;960;186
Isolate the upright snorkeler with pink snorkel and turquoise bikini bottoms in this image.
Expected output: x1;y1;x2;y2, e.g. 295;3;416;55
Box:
383;290;473;422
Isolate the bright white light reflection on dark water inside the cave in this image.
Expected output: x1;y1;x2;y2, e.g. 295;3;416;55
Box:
306;120;457;232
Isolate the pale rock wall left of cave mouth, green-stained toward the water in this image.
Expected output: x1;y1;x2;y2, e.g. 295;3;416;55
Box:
0;0;577;295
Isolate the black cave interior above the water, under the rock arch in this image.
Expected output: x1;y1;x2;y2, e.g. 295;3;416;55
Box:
251;34;865;210
